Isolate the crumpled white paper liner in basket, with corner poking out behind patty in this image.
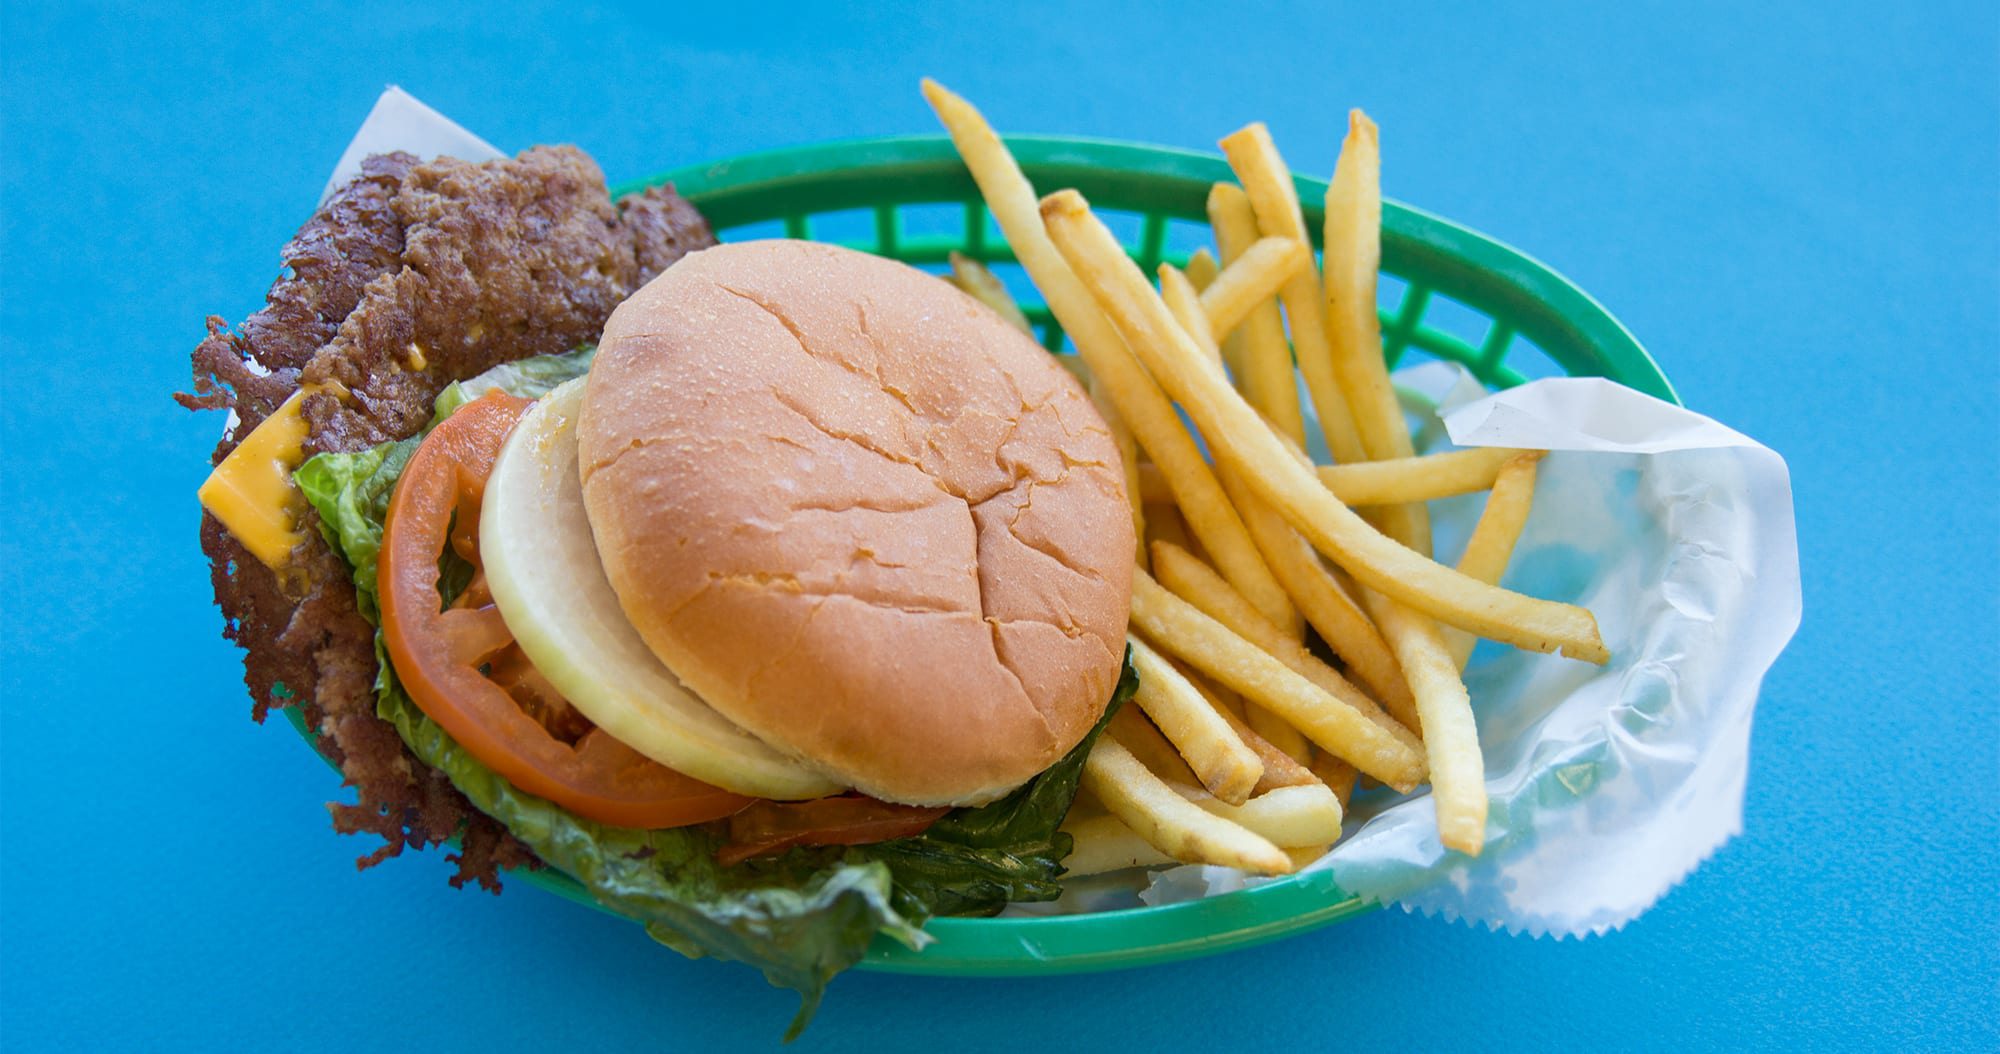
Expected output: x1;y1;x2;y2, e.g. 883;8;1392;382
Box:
328;86;1800;936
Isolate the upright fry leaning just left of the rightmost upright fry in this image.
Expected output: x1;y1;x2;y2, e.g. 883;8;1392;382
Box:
1204;122;1366;464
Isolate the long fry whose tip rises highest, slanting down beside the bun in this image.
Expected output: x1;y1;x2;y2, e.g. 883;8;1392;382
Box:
924;78;1296;636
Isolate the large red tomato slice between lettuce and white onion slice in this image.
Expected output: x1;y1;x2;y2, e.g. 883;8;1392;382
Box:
378;392;750;828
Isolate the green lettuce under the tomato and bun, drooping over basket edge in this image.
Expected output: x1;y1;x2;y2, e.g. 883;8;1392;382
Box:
296;348;1138;1040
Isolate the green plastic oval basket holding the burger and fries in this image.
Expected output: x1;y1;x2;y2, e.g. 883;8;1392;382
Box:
286;136;1678;976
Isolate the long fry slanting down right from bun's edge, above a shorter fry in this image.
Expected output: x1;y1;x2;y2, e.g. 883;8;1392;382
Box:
1132;572;1424;790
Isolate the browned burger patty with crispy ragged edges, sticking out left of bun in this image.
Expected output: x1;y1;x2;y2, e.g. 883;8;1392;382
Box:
176;146;716;890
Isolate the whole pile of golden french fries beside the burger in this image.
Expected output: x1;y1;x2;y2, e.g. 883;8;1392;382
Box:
924;80;1608;874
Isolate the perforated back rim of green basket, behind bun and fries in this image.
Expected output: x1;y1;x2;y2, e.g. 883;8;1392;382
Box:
614;136;1680;404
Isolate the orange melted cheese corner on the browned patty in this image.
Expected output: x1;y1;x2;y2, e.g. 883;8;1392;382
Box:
196;390;306;570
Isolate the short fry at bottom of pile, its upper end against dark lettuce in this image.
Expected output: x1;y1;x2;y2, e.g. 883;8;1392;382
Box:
1082;736;1292;874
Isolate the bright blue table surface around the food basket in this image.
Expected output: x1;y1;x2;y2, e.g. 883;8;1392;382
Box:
0;0;2000;1050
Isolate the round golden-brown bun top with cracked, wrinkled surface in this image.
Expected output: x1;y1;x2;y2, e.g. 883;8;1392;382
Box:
578;240;1134;804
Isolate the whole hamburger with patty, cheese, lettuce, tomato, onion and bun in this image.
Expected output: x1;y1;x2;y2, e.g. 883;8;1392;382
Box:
178;148;1136;1024
